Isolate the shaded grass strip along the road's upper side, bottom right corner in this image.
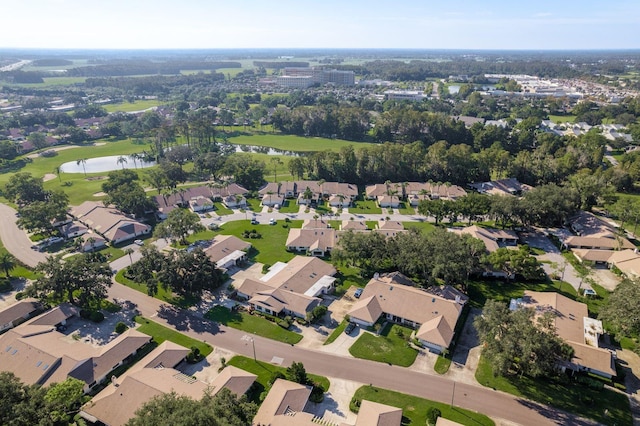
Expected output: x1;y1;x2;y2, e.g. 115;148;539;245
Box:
476;356;633;425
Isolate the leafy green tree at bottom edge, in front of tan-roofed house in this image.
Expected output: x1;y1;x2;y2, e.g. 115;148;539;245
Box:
127;388;258;426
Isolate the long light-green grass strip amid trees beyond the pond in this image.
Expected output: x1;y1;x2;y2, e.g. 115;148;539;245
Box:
228;132;374;152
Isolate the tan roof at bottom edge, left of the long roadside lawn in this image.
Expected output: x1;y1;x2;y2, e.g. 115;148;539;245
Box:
253;379;311;426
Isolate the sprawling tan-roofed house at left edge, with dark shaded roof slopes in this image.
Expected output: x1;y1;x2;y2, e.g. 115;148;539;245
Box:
0;304;151;393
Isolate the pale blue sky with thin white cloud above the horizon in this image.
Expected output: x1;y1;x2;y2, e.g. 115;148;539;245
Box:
5;0;640;49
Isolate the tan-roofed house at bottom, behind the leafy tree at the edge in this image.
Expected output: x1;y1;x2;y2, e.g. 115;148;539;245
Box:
80;341;256;426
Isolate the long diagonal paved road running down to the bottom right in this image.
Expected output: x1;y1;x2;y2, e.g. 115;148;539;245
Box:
109;283;593;425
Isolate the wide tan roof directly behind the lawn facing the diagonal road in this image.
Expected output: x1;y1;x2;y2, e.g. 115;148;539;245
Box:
349;278;462;347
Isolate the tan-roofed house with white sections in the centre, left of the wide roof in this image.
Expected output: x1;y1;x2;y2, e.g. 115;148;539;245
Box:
236;256;336;318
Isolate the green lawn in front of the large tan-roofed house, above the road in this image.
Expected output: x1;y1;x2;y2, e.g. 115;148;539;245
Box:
349;324;418;367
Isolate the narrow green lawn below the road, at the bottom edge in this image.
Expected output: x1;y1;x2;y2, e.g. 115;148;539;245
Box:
349;386;495;426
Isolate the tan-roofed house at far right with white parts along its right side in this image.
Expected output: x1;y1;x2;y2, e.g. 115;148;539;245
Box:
510;290;616;378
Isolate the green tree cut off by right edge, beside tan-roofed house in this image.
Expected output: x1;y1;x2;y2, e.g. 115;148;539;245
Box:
598;278;640;338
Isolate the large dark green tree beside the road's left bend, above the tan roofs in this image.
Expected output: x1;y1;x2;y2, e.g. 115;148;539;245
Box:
29;253;113;309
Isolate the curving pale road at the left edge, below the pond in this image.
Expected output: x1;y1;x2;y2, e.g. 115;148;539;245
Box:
0;203;47;268
